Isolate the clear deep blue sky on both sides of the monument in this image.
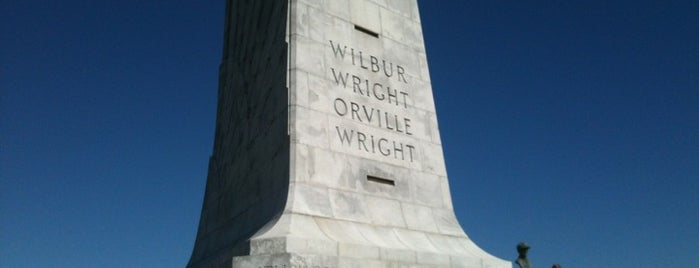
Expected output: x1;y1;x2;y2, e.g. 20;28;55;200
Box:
0;0;699;268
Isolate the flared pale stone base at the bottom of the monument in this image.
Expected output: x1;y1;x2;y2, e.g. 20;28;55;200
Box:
216;214;512;268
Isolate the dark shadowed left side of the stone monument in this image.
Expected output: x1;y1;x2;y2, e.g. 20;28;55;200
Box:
187;0;289;268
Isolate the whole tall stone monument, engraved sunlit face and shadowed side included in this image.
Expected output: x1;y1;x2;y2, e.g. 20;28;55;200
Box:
187;0;512;268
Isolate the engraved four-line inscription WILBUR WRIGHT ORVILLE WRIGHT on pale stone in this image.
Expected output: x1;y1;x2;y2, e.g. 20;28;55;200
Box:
329;40;416;162
